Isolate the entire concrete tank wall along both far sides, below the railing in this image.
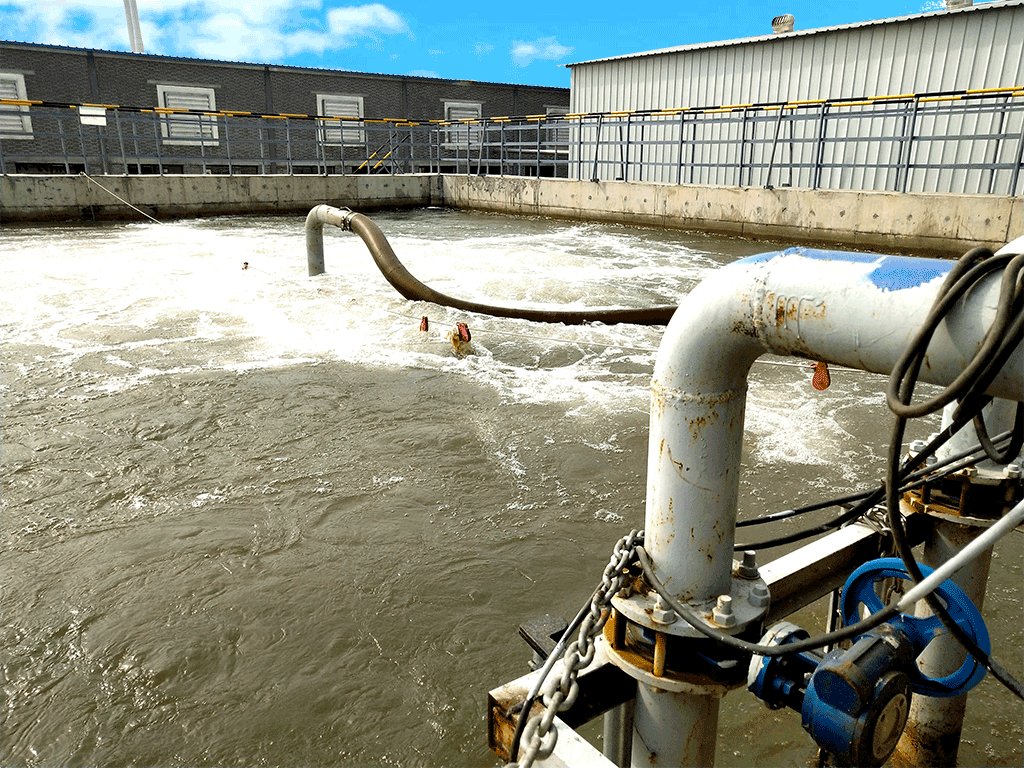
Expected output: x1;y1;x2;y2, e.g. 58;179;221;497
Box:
0;174;1024;256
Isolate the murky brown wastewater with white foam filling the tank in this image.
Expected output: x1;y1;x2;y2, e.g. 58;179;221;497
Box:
0;209;1022;766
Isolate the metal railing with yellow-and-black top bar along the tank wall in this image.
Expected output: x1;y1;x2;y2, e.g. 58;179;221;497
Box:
0;87;1024;195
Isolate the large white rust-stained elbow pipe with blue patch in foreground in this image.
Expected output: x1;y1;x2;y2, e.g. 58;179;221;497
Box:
634;248;1024;765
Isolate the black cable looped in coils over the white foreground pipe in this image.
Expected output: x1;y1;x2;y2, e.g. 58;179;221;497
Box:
886;249;1024;699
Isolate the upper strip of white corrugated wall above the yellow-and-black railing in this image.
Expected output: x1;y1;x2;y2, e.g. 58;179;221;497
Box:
570;3;1024;113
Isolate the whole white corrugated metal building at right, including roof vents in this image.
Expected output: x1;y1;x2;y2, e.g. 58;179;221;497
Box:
569;0;1024;191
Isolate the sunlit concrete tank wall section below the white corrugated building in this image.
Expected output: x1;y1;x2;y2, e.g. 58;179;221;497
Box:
442;176;1024;256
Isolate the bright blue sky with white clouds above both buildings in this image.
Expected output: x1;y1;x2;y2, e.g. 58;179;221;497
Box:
0;0;958;87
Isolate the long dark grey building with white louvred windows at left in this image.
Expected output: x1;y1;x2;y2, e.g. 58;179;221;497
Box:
0;41;569;173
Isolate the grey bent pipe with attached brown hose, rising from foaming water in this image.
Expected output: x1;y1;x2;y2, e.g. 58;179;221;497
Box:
306;205;676;326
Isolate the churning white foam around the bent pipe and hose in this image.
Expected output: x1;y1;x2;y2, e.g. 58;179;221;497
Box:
0;211;729;423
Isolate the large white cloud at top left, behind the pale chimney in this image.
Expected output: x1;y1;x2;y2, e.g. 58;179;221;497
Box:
0;0;411;61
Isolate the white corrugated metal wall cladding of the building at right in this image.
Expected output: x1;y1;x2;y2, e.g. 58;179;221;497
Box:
570;0;1024;190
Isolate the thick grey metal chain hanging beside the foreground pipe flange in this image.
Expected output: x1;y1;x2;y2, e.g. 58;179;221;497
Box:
510;530;643;768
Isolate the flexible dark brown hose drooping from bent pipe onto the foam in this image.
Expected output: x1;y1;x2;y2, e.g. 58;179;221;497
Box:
344;213;676;326
